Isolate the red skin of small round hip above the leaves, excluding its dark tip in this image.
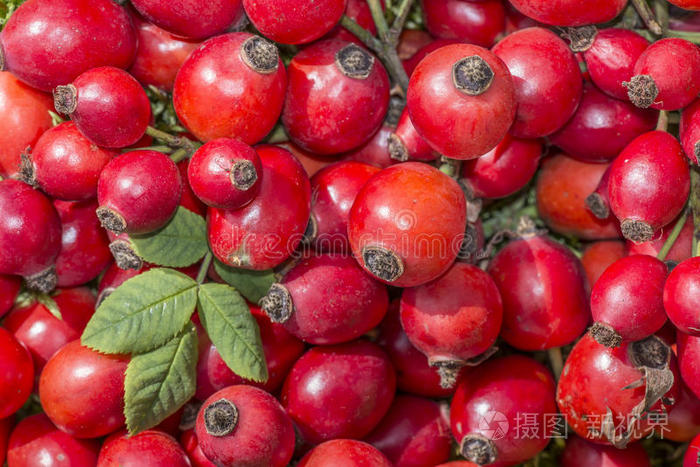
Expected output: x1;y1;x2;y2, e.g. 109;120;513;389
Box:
187;138;263;209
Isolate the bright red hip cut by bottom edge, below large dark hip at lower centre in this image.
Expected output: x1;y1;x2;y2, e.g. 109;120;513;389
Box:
297;439;393;467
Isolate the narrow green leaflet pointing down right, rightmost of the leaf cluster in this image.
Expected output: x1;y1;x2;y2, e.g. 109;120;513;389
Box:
198;283;268;382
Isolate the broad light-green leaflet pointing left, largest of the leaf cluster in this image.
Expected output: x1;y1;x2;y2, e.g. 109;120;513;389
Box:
81;269;197;354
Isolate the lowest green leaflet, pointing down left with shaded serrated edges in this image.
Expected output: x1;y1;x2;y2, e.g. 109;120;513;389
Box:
124;324;197;435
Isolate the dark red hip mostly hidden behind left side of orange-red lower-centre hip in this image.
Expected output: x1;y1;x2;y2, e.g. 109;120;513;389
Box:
376;301;455;398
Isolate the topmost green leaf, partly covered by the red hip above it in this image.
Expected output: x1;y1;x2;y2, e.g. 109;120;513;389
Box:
130;206;209;268
